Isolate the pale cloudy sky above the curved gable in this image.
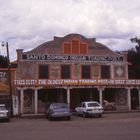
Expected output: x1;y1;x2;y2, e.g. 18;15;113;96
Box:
0;0;140;61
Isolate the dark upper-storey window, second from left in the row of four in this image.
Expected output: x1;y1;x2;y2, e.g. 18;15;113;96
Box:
61;65;70;79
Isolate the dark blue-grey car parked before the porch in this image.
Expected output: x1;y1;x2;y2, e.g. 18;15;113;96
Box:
45;103;72;120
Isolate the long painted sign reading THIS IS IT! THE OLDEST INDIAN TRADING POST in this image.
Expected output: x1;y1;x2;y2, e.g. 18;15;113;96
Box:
14;79;140;86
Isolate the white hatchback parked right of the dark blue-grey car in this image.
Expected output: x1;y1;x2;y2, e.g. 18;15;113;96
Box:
75;101;104;118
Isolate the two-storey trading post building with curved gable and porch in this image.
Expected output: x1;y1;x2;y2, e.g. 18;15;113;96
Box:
14;34;140;114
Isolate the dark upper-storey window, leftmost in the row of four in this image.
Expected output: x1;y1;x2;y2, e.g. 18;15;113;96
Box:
39;65;49;79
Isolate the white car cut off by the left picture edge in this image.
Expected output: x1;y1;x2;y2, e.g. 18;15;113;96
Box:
0;104;9;121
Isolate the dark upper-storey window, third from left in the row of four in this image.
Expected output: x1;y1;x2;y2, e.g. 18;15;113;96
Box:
81;65;90;79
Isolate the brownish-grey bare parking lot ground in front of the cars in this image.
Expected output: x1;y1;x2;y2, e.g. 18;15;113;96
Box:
0;112;140;140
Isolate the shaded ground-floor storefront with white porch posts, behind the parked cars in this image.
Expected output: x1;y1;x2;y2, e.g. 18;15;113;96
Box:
15;82;140;113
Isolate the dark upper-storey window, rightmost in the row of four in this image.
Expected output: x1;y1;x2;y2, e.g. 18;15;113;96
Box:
101;65;110;79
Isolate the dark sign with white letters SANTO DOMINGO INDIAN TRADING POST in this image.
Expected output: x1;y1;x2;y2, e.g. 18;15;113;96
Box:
21;54;124;62
